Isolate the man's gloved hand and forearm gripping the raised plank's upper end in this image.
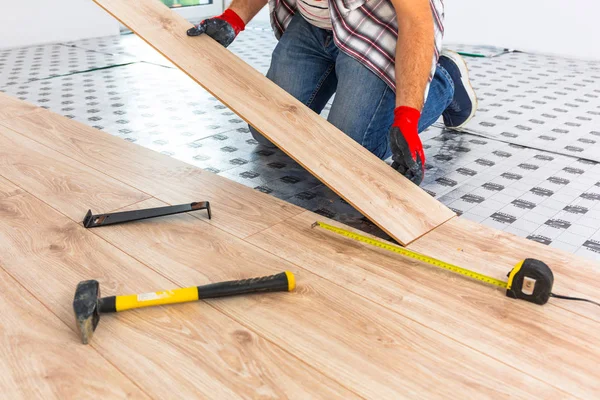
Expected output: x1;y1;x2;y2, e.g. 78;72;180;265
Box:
187;0;268;47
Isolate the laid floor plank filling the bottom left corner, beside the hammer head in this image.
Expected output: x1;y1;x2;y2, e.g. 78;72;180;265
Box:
0;268;148;400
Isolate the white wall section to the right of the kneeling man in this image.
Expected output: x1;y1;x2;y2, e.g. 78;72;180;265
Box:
444;0;600;60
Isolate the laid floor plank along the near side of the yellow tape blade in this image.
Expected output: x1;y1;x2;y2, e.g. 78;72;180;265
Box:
246;212;600;398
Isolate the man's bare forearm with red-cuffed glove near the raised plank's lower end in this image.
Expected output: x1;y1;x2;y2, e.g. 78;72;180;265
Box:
390;0;435;185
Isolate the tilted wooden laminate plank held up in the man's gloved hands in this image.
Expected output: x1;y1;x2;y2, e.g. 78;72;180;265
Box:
89;0;454;244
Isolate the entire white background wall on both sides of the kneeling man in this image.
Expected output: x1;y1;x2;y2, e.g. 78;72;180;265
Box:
0;0;600;60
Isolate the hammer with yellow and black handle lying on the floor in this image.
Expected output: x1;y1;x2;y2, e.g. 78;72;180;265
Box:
73;271;296;344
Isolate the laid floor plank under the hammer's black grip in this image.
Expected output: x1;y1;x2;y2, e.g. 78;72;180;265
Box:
94;199;565;399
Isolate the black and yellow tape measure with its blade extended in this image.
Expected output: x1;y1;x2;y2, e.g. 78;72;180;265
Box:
312;221;564;304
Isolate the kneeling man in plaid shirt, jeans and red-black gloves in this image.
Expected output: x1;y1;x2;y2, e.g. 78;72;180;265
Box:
187;0;477;185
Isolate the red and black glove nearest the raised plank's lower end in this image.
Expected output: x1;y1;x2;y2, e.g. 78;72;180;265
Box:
390;106;425;185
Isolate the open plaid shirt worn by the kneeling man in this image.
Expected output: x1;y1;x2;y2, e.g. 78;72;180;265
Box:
269;0;444;97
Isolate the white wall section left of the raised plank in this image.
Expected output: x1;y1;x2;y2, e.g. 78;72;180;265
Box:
0;0;119;48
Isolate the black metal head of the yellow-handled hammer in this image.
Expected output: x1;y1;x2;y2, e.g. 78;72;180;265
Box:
73;280;100;344
